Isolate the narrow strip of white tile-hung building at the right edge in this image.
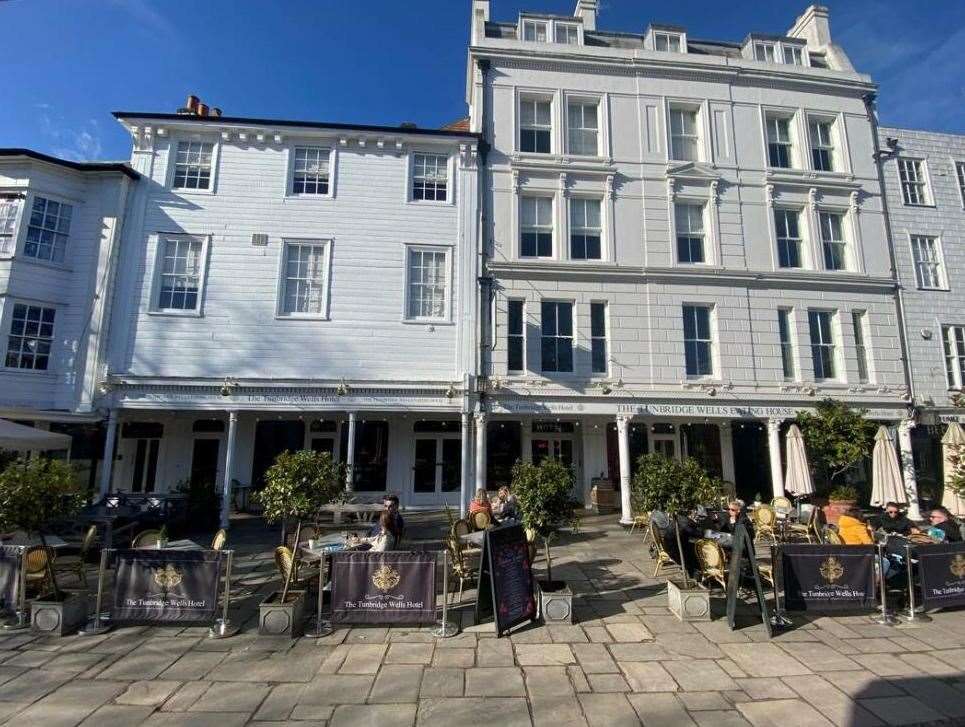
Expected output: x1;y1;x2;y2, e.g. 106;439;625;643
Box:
879;127;965;502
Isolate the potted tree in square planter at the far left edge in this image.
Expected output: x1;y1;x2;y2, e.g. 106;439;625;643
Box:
0;457;87;636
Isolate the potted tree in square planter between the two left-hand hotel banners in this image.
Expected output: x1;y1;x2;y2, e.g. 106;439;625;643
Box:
254;450;345;636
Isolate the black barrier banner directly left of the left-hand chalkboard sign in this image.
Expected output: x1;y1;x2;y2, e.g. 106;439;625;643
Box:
332;551;436;624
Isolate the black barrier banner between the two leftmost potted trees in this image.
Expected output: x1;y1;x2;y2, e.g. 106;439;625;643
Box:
111;548;223;624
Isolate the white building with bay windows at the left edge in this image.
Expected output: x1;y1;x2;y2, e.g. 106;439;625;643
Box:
0;149;138;483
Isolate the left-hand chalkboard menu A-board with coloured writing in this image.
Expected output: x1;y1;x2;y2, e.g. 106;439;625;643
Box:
476;525;536;636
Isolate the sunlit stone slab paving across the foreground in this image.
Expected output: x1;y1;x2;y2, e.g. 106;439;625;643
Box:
0;517;965;727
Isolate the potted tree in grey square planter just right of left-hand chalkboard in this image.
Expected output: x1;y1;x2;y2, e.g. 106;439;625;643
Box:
512;457;577;623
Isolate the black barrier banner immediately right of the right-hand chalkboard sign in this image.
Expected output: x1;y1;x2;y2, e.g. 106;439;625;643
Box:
781;543;876;611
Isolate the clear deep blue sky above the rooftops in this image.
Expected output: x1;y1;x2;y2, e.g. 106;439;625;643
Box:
0;0;965;159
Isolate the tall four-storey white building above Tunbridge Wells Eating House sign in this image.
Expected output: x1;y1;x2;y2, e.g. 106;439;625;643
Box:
467;0;914;521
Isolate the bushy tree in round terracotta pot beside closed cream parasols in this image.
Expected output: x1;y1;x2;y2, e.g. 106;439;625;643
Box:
796;399;875;523
